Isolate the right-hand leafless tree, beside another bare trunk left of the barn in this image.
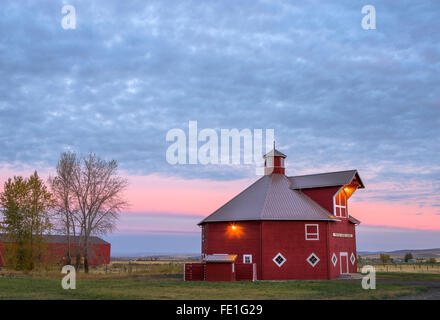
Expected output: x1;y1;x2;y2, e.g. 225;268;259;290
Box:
72;153;128;272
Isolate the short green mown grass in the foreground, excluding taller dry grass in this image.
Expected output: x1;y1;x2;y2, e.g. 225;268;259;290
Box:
0;276;425;300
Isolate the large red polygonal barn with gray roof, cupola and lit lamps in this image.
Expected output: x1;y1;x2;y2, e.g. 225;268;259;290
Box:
189;149;364;280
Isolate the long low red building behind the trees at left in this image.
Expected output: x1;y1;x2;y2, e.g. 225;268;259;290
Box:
0;234;111;267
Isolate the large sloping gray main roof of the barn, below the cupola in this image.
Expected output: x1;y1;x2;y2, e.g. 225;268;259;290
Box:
199;174;335;224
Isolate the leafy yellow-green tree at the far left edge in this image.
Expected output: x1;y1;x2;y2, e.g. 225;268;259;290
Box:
0;171;54;270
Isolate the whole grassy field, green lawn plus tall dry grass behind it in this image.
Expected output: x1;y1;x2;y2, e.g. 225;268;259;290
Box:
0;261;434;300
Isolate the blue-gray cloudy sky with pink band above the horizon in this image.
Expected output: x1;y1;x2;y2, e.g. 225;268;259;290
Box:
0;0;440;253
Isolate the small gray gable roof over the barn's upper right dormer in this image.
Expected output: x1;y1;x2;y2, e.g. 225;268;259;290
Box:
289;170;364;189
